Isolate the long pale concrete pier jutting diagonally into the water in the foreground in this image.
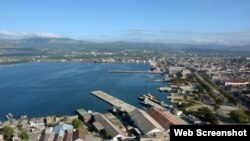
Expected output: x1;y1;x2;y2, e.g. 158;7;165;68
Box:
91;91;136;113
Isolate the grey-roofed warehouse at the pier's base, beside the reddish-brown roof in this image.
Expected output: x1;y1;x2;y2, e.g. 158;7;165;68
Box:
129;109;164;135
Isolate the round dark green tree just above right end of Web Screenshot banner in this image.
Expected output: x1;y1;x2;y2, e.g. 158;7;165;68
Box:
230;110;248;123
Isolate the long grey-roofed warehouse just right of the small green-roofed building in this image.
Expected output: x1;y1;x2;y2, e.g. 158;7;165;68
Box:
93;113;127;141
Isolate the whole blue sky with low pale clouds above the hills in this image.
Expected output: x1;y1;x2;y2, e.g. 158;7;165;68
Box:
0;0;250;44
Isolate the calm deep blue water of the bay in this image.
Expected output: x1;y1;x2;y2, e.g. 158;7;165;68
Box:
0;63;170;120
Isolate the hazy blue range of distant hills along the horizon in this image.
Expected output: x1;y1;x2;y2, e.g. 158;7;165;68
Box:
0;37;250;55
